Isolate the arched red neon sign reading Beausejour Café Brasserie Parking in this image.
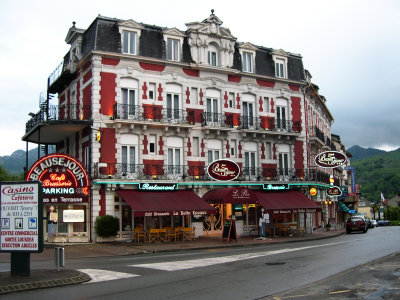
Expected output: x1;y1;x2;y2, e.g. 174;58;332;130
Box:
26;153;90;203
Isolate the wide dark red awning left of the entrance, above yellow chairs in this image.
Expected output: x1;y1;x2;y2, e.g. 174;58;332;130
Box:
117;190;216;217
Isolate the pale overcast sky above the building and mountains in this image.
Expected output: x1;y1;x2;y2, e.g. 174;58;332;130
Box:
0;0;400;156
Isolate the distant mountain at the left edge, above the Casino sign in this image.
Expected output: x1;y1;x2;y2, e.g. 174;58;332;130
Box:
0;148;43;175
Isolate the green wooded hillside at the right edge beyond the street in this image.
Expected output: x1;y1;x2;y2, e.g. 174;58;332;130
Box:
349;147;400;202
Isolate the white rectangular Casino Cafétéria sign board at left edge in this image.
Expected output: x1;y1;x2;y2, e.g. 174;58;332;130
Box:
0;181;43;252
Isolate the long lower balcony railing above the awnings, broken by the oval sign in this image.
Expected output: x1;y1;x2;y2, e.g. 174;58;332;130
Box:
93;163;329;184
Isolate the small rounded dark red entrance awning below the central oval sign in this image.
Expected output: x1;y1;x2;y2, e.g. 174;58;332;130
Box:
203;187;258;204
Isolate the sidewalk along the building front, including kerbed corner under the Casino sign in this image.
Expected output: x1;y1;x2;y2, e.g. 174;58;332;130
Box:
0;229;345;294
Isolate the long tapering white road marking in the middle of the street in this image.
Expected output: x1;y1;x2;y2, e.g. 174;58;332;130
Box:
129;242;344;271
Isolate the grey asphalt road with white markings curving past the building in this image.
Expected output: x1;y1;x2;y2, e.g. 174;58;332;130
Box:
0;227;400;300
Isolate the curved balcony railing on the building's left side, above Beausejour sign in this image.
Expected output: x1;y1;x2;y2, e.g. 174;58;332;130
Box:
25;104;92;132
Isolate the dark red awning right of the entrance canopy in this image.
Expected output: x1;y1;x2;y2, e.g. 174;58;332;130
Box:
256;191;321;214
